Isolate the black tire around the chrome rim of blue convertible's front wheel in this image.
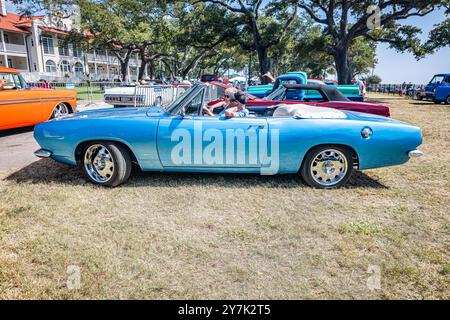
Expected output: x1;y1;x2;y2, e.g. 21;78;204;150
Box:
81;141;132;187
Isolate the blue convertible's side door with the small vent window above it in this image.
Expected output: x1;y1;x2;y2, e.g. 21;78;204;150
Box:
157;88;267;172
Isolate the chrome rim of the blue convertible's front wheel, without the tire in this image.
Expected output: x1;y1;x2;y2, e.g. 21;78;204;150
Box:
84;144;114;183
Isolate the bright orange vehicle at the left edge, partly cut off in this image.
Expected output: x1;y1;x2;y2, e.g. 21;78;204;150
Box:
0;67;77;130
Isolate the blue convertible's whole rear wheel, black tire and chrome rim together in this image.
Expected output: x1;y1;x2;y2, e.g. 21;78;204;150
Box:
301;145;353;189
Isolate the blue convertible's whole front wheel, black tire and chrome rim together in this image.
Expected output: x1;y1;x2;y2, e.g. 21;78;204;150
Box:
81;141;132;187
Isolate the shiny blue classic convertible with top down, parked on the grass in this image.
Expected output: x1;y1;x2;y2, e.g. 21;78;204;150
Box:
34;83;422;189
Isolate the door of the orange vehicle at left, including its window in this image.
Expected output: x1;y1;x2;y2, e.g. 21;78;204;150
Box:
0;73;43;129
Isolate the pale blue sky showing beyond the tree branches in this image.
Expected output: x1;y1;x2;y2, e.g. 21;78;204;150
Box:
7;1;450;84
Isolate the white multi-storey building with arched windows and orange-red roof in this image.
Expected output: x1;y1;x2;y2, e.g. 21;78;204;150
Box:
0;0;140;82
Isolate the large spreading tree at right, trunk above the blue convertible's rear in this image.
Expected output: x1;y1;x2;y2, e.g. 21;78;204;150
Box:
298;0;448;84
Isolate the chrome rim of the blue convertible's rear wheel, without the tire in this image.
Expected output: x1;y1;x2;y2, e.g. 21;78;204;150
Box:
310;149;348;187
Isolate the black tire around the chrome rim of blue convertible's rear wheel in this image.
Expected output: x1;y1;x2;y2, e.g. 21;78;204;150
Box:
300;145;353;189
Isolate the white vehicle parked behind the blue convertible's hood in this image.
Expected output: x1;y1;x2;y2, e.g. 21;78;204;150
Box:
104;84;190;108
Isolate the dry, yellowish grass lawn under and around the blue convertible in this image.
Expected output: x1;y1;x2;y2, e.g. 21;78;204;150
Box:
0;94;450;299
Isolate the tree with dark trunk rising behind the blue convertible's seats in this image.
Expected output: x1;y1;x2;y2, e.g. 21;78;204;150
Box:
194;0;297;83
